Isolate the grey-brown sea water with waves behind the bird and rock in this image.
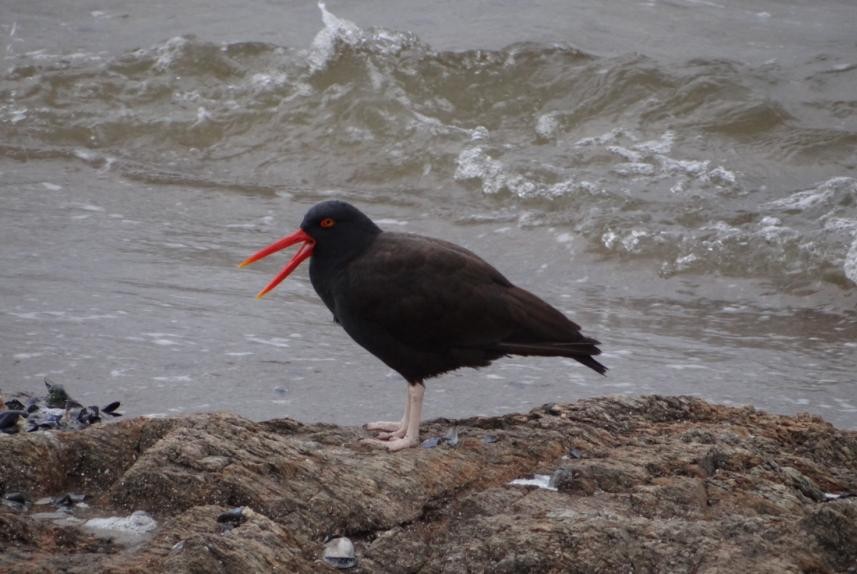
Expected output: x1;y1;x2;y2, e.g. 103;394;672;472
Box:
0;0;857;428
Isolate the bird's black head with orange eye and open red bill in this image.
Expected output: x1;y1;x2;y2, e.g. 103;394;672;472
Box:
239;200;381;299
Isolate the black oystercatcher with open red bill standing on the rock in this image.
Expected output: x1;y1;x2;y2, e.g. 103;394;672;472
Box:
241;201;607;450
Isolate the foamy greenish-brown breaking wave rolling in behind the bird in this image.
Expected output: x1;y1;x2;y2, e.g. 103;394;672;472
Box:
0;4;857;290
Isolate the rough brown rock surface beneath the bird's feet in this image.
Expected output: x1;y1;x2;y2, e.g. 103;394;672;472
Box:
0;396;857;574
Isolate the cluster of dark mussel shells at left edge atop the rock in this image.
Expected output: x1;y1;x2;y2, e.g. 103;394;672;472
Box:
0;378;122;434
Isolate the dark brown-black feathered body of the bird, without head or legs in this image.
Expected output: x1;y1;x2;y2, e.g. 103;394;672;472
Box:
310;232;606;382
